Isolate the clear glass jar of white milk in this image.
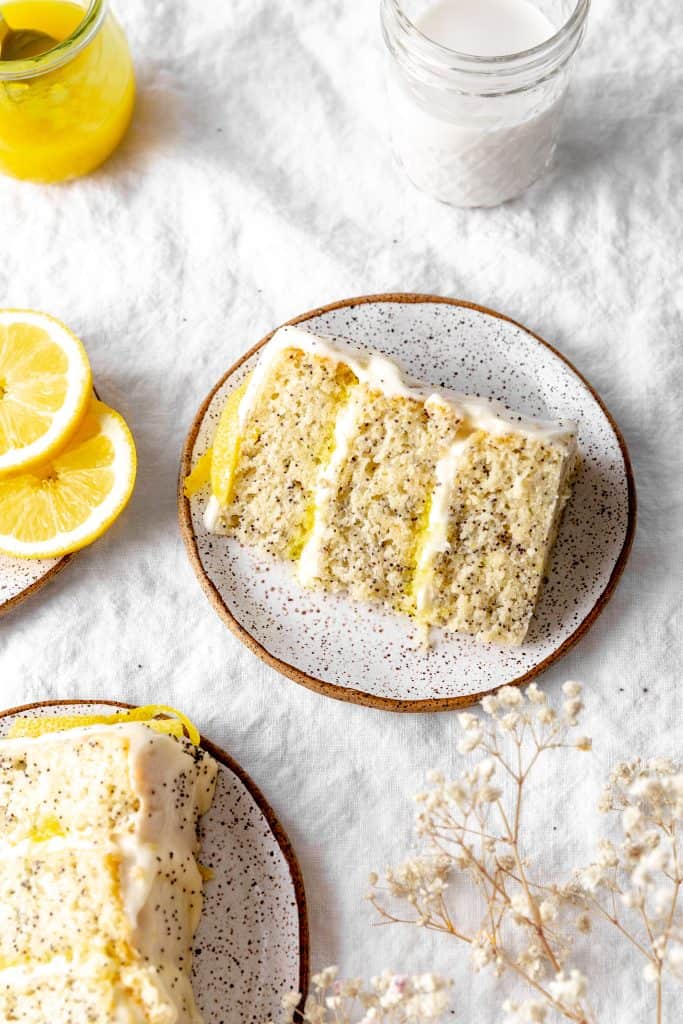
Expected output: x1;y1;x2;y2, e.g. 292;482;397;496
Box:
381;0;590;207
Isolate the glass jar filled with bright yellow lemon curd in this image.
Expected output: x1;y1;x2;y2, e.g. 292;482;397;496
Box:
0;0;135;182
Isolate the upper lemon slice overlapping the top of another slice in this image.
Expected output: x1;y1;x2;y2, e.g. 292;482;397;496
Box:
0;309;92;476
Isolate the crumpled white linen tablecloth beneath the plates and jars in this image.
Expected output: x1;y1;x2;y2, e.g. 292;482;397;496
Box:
0;0;683;1024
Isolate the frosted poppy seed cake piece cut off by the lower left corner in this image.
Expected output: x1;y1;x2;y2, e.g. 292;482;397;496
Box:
0;720;216;1024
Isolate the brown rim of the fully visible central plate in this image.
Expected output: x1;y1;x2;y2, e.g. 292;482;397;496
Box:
178;292;637;714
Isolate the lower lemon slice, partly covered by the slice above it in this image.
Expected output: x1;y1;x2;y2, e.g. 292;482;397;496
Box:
0;398;136;558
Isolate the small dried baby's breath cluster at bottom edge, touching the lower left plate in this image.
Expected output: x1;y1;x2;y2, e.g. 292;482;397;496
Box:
270;967;452;1024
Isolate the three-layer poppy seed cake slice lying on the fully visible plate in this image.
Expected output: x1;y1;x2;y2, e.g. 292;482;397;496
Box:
200;327;577;644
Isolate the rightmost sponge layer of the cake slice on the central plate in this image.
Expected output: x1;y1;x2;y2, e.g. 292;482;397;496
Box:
416;431;573;644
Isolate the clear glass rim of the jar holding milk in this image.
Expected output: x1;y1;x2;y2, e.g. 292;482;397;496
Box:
382;0;591;77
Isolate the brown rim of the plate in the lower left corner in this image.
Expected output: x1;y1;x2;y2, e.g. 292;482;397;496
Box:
0;698;310;1005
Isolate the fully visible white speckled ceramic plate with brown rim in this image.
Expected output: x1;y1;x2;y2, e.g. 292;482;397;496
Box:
179;295;636;712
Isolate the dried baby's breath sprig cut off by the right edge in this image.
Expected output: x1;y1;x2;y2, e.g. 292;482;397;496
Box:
577;758;683;1024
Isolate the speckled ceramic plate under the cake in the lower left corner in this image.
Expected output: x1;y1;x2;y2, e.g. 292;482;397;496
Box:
0;700;308;1024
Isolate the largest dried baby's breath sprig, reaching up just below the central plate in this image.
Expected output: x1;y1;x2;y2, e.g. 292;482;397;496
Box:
368;682;593;1024
